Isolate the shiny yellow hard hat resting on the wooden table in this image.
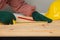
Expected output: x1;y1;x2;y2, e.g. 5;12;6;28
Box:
45;0;60;20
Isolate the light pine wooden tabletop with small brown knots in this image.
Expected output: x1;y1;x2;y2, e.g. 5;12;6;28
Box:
0;13;60;37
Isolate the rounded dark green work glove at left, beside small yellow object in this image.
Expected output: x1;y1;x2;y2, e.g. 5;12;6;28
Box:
0;11;16;24
